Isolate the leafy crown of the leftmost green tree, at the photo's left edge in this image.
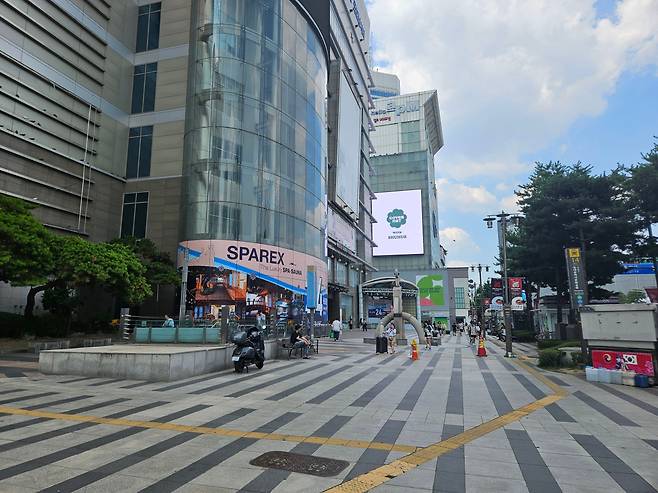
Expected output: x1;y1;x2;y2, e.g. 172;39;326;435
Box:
0;194;53;286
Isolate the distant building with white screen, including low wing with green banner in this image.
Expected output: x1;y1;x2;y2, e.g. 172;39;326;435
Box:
363;88;468;326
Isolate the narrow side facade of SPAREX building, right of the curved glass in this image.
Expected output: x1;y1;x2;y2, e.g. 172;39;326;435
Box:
327;0;374;322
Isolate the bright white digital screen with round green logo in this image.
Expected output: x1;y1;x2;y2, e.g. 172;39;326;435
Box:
372;190;424;256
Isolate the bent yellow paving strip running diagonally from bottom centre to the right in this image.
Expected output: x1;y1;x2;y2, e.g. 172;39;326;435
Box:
325;359;568;493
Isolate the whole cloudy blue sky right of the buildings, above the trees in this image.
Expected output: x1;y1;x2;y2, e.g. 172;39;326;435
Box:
368;0;658;276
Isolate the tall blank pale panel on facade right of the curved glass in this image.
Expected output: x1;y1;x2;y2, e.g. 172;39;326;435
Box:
336;73;361;215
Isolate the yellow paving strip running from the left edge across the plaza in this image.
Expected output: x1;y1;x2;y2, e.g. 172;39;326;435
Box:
0;406;418;453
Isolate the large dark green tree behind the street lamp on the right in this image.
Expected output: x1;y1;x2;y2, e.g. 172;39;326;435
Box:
508;162;638;322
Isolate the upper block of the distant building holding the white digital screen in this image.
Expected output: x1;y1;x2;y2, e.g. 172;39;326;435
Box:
371;91;445;271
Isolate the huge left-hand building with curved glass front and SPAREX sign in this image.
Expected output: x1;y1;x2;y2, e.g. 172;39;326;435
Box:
0;0;373;319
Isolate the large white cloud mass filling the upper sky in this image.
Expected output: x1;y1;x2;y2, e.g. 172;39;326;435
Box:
369;0;658;180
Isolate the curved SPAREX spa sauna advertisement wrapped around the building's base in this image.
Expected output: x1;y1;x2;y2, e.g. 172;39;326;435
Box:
178;240;327;323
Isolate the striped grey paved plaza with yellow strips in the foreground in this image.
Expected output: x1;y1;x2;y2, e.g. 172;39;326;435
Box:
0;332;658;493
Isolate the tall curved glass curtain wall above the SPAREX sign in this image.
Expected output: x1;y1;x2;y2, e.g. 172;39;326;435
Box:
181;0;327;258
